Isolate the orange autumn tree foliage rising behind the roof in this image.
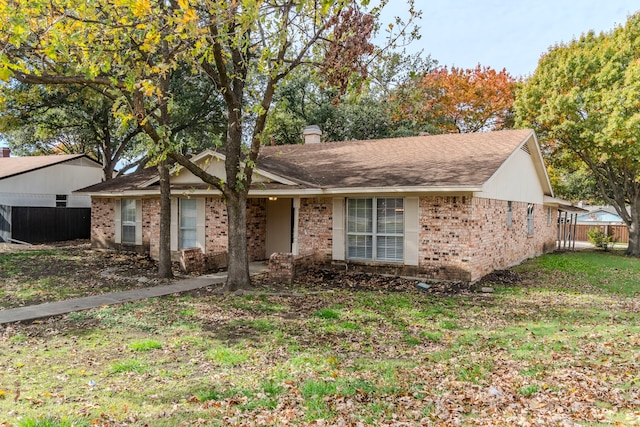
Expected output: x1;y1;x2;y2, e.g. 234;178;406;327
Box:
392;65;516;133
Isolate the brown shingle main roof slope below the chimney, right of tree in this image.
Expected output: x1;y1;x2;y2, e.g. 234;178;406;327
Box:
258;129;532;188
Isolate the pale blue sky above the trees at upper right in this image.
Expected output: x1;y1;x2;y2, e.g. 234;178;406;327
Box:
408;0;640;77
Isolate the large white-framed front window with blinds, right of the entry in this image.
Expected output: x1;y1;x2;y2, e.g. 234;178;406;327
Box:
347;198;404;261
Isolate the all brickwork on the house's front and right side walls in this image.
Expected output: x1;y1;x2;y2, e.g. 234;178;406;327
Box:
91;196;557;280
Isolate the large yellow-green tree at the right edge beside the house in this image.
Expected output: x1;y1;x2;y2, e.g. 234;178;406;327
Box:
516;14;640;256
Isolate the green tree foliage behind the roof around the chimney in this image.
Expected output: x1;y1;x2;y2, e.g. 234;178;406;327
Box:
265;51;435;145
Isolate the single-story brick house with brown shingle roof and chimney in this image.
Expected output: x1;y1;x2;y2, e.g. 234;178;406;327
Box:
82;130;562;281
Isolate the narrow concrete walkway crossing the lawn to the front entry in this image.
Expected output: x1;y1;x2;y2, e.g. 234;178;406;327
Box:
0;263;269;325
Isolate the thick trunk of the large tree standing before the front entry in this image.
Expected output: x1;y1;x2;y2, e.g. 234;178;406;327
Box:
224;191;251;292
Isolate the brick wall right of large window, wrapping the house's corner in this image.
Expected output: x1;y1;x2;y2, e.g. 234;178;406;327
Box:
419;196;557;280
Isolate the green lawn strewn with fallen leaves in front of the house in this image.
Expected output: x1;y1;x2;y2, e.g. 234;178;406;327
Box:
0;252;640;427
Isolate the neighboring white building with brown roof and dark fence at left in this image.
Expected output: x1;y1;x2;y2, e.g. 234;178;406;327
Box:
0;147;103;242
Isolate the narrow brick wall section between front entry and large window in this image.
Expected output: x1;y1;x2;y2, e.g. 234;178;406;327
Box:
298;197;333;260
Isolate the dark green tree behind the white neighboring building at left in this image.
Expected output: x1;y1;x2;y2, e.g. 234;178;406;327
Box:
0;83;148;180
